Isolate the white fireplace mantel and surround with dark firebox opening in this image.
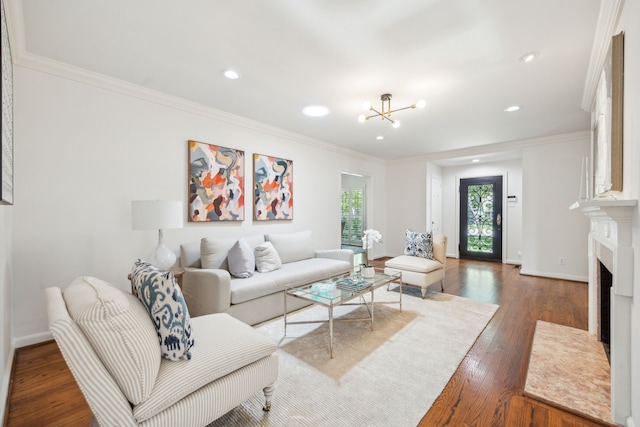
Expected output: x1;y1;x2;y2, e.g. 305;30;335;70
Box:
571;199;637;424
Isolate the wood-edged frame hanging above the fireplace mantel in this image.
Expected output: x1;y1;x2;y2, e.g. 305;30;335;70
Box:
593;33;624;197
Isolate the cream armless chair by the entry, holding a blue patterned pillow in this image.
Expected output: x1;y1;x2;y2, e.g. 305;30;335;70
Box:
384;234;447;298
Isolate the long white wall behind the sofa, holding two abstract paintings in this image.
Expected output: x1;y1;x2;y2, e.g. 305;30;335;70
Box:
11;67;386;346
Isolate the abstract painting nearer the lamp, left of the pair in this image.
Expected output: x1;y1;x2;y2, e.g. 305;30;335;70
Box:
189;141;244;222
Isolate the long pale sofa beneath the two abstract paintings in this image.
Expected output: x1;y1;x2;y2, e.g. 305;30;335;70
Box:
180;230;353;325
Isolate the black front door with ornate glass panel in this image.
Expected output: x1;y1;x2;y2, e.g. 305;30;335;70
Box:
460;176;503;262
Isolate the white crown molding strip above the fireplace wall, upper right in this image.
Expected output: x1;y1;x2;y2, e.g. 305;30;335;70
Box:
581;0;624;113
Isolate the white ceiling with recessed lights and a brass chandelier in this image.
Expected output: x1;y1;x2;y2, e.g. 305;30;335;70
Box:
12;0;600;160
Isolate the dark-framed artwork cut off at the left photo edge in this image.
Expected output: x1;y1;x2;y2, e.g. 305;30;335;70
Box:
0;1;13;205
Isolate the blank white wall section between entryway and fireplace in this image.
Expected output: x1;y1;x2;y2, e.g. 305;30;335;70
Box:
521;136;590;282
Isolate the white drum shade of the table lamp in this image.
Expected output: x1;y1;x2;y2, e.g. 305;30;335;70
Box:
131;200;182;230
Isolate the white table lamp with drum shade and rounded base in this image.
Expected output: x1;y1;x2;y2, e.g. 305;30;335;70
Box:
131;200;182;270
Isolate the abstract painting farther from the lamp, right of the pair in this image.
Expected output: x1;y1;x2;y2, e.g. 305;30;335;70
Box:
253;154;293;221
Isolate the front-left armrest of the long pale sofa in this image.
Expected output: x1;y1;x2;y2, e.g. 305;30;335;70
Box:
182;268;231;317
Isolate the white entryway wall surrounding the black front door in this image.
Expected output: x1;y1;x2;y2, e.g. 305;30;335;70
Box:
442;159;523;264
